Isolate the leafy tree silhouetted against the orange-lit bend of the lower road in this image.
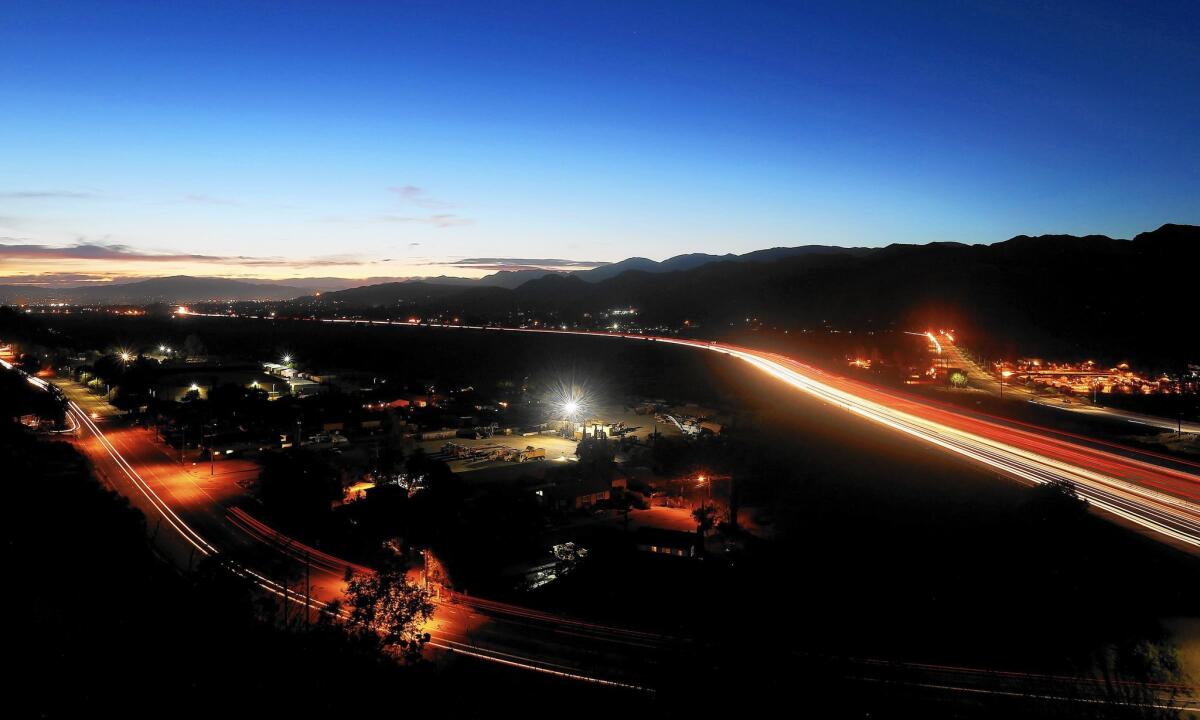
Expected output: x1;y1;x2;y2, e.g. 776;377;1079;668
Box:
344;568;433;662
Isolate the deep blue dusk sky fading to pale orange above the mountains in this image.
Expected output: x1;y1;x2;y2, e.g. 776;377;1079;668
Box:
0;0;1200;284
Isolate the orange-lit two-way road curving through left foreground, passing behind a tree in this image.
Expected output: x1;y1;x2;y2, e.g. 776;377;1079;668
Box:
56;380;680;690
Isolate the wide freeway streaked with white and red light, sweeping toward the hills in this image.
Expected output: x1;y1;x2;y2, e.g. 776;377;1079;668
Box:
187;313;1200;553
